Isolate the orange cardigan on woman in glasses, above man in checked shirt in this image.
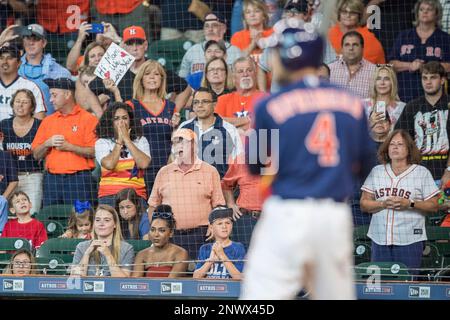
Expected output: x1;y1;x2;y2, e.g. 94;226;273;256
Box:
328;24;386;64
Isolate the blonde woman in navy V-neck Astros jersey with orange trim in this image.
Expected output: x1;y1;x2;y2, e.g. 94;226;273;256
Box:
127;60;175;194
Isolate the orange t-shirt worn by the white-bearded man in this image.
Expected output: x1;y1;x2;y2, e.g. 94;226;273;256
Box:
215;90;264;118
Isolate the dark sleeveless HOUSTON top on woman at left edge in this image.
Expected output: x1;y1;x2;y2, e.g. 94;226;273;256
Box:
0;118;43;172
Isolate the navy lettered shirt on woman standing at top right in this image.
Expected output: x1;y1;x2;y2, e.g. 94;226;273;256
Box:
388;28;450;102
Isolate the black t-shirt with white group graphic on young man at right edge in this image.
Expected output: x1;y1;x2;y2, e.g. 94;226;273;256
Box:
395;95;450;180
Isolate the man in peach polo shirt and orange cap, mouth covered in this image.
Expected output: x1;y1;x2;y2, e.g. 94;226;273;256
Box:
148;128;225;259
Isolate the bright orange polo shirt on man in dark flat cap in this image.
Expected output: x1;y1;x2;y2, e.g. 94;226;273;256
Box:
31;105;98;174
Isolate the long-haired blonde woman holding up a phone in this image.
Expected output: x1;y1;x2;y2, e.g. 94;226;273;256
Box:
363;65;406;127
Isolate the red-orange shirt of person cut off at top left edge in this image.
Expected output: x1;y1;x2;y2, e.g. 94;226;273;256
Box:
36;0;89;33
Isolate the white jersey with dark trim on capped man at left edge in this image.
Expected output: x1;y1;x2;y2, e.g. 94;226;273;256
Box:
0;76;47;121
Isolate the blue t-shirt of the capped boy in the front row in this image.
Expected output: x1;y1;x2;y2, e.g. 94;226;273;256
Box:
195;242;245;279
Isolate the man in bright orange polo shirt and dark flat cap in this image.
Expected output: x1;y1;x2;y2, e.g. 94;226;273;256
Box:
31;78;98;206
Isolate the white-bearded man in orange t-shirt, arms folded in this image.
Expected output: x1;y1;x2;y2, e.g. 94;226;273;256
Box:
215;57;264;130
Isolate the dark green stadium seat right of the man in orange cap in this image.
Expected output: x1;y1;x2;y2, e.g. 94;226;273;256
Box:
147;39;192;72
